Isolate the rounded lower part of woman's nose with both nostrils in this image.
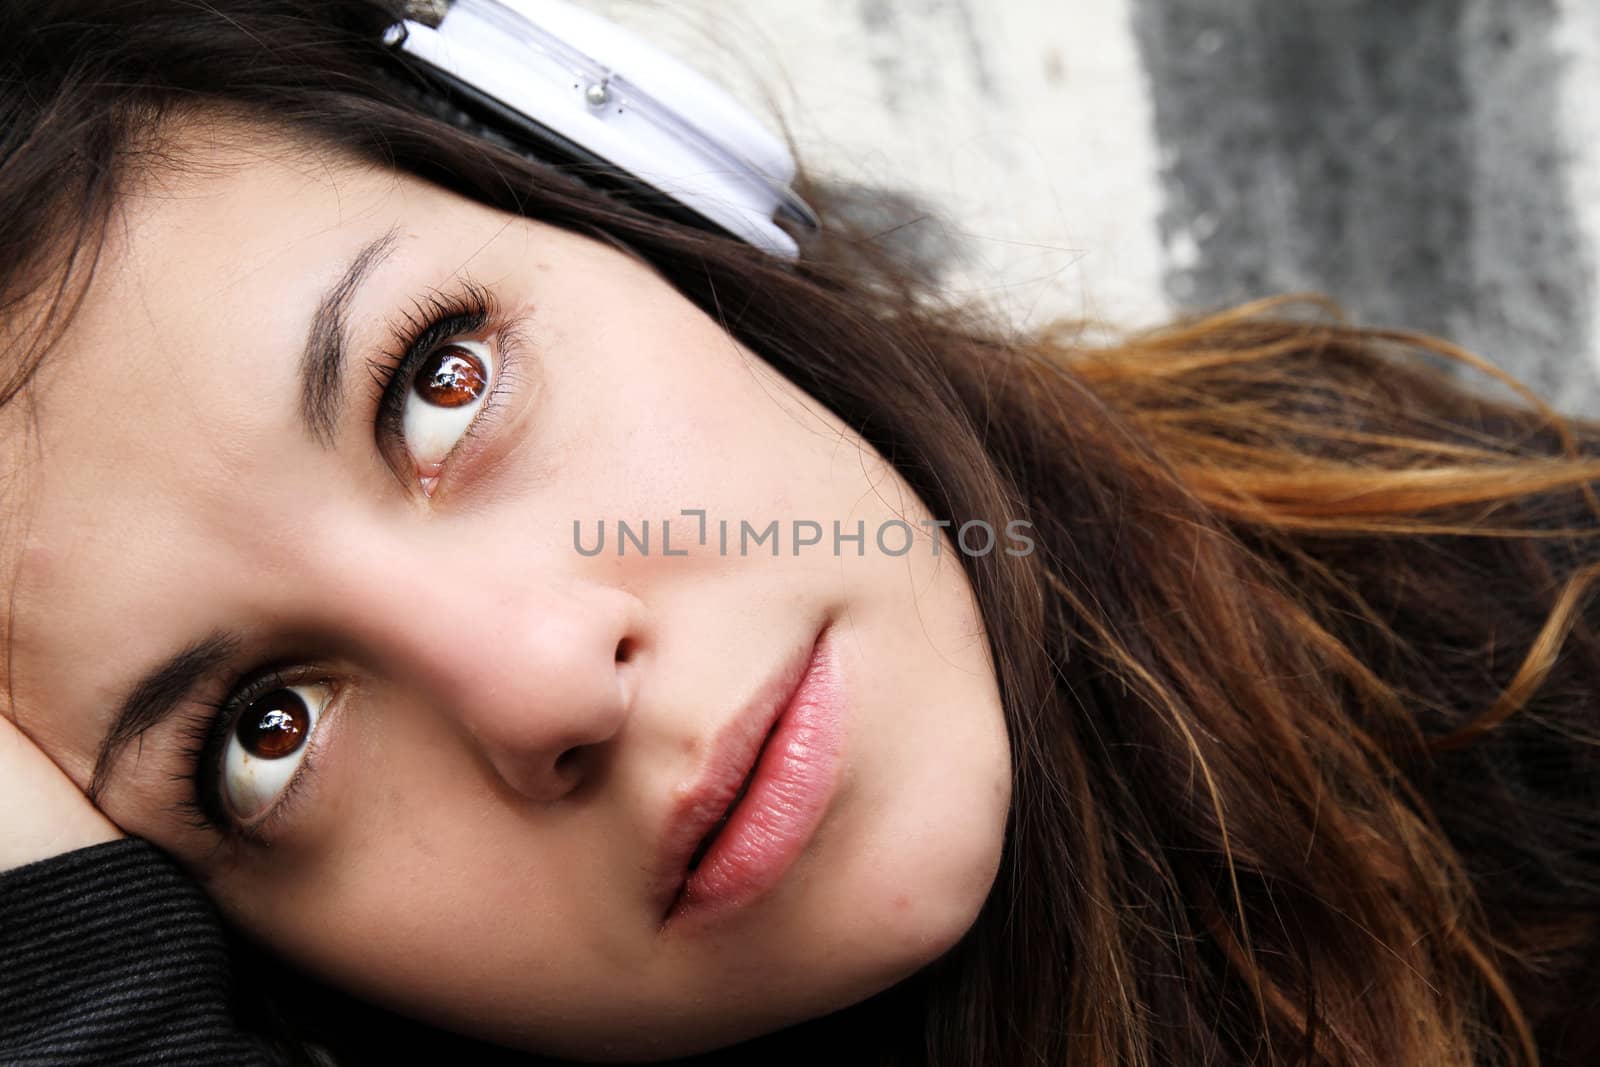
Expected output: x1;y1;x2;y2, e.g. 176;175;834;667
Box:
358;576;645;803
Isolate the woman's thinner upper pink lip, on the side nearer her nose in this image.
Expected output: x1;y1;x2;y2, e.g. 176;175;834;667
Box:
656;637;816;912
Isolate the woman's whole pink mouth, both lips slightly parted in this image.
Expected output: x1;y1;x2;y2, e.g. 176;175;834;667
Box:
661;627;843;929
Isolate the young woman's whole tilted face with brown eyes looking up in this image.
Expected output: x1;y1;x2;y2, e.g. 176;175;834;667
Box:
5;131;1011;1059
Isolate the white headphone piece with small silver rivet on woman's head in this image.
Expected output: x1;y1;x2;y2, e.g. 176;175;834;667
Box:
384;0;819;258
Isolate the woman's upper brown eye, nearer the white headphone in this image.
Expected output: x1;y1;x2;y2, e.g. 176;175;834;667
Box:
400;341;496;473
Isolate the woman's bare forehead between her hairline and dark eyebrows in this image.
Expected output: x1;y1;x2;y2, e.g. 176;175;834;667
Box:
0;123;491;781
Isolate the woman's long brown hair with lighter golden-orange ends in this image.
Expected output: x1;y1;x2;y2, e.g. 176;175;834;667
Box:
9;0;1600;1067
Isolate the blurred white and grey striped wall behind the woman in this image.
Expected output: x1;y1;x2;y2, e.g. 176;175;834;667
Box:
586;0;1600;416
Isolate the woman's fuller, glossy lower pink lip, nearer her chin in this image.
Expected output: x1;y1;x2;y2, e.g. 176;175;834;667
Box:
666;629;845;926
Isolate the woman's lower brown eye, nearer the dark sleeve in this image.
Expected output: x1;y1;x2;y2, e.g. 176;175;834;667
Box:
222;681;333;822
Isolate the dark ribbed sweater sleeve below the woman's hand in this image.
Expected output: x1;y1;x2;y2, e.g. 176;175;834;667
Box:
0;838;277;1067
